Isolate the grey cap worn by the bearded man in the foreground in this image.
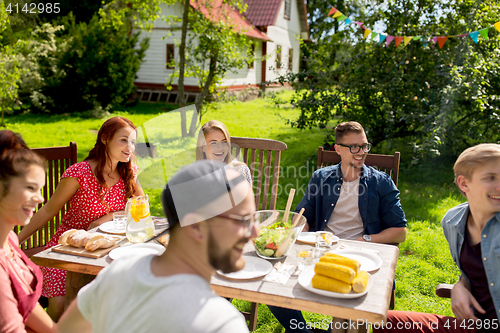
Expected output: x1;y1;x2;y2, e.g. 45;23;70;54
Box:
161;160;246;229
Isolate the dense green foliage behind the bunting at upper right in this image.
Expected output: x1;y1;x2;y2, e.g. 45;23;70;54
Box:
280;0;500;155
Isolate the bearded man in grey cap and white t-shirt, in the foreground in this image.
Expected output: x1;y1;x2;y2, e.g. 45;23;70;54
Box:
58;160;257;333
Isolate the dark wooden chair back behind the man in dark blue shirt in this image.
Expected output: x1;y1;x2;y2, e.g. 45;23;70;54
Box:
318;146;400;186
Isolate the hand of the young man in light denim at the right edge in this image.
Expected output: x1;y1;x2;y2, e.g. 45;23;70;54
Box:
451;278;486;320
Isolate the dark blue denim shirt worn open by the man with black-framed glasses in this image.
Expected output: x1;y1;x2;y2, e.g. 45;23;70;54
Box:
296;163;406;235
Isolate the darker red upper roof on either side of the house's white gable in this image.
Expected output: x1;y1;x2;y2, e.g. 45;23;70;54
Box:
244;0;309;39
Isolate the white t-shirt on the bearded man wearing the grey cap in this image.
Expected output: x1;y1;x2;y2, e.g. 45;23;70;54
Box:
78;255;248;333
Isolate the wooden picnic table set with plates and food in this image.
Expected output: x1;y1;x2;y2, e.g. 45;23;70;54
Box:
31;240;399;332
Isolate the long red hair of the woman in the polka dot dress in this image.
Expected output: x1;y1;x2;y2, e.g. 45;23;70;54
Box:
85;117;137;202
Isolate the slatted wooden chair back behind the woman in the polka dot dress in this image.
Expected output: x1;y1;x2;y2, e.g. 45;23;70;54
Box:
14;142;77;257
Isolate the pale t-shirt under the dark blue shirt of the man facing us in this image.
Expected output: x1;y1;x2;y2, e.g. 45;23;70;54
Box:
327;177;364;239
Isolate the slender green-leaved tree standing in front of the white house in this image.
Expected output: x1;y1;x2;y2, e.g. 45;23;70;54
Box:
165;0;252;136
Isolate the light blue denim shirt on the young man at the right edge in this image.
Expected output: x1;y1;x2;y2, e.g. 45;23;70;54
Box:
441;202;500;320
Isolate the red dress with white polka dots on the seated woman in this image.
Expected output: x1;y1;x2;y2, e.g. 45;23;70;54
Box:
40;161;138;298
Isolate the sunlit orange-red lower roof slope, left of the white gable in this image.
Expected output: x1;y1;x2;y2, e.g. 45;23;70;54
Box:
189;0;271;42
